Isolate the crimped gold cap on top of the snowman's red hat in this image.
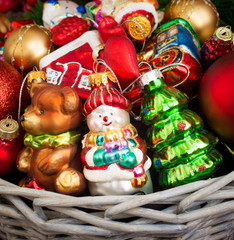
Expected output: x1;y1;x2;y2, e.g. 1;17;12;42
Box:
89;72;117;87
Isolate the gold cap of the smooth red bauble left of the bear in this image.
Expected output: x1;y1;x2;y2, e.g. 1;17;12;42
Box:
0;116;19;141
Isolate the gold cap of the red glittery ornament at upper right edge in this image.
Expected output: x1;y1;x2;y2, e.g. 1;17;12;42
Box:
214;26;233;45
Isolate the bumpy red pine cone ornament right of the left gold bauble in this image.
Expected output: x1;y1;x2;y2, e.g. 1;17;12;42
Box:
52;16;89;46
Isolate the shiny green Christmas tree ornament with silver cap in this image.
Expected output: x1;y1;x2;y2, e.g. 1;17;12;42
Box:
140;69;222;187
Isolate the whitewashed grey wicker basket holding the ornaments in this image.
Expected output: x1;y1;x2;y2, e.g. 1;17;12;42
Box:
0;168;234;240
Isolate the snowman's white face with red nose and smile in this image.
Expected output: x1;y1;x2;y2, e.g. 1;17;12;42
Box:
87;105;130;132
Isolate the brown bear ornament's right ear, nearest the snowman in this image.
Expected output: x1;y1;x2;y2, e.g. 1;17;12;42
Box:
62;86;82;112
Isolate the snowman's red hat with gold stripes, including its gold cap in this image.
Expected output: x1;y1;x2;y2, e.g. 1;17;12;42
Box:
83;72;132;116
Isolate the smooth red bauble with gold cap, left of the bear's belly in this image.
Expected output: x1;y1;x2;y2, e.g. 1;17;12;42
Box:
0;118;23;176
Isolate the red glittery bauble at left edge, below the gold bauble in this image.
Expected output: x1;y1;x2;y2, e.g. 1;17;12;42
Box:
0;60;30;120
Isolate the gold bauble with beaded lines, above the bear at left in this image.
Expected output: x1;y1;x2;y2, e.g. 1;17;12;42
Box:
3;24;53;75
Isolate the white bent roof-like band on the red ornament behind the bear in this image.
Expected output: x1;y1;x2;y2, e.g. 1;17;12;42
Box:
39;30;101;70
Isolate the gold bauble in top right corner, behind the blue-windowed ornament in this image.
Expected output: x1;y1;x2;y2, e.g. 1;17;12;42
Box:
163;0;219;44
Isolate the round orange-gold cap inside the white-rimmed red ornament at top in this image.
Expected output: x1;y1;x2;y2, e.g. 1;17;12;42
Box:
127;15;152;40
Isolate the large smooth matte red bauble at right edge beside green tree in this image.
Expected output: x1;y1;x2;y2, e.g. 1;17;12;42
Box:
199;52;234;145
